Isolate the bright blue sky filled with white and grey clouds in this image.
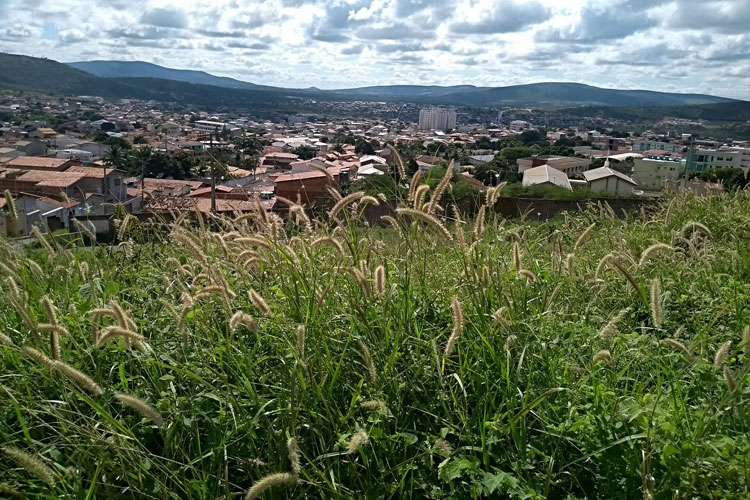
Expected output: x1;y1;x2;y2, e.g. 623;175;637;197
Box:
0;0;750;100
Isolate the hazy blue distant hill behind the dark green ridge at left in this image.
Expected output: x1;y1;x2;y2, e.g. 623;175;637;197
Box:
67;61;279;90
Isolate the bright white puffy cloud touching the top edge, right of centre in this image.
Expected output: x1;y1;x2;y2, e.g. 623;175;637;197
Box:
450;0;552;35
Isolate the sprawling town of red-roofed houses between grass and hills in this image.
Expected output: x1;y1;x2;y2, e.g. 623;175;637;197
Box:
0;94;750;236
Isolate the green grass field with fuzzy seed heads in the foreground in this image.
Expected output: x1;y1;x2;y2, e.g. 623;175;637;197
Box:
0;188;750;500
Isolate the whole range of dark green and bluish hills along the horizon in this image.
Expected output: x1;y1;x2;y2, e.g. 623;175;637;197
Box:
0;53;750;121
